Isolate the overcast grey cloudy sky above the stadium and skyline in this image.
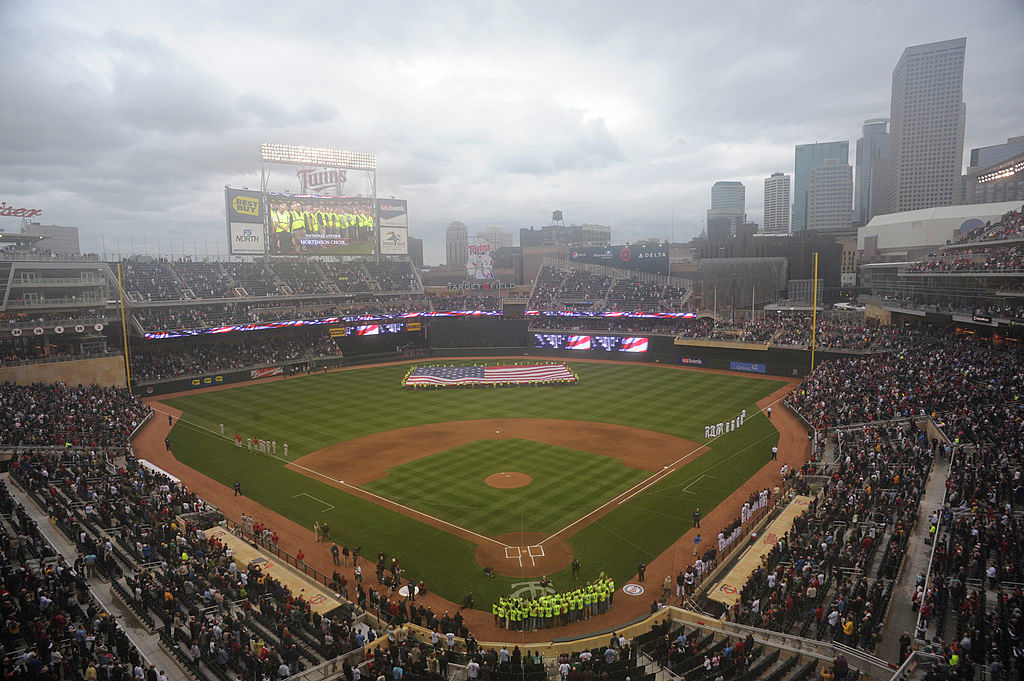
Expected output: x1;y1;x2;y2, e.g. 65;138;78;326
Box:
0;0;1024;262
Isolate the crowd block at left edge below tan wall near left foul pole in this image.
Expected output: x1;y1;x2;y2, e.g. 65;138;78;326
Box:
0;382;151;446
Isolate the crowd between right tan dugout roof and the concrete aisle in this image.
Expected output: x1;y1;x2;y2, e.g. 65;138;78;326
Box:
732;422;938;650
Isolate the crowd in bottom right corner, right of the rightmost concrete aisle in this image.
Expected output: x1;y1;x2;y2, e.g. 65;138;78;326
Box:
908;405;1024;678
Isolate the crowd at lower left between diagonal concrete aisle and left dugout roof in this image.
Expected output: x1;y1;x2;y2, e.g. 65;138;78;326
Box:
12;451;364;681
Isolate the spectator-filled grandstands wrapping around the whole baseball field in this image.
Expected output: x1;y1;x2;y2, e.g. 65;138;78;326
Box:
6;206;1024;681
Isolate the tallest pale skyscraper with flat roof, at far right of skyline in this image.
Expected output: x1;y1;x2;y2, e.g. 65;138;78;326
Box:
889;38;967;213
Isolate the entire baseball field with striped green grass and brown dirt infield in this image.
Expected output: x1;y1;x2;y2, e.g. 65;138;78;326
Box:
162;361;785;607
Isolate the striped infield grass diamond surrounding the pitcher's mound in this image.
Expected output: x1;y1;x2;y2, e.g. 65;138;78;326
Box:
362;439;650;537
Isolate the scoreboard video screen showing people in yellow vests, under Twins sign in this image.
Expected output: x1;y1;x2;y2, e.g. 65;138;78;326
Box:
267;194;377;255
